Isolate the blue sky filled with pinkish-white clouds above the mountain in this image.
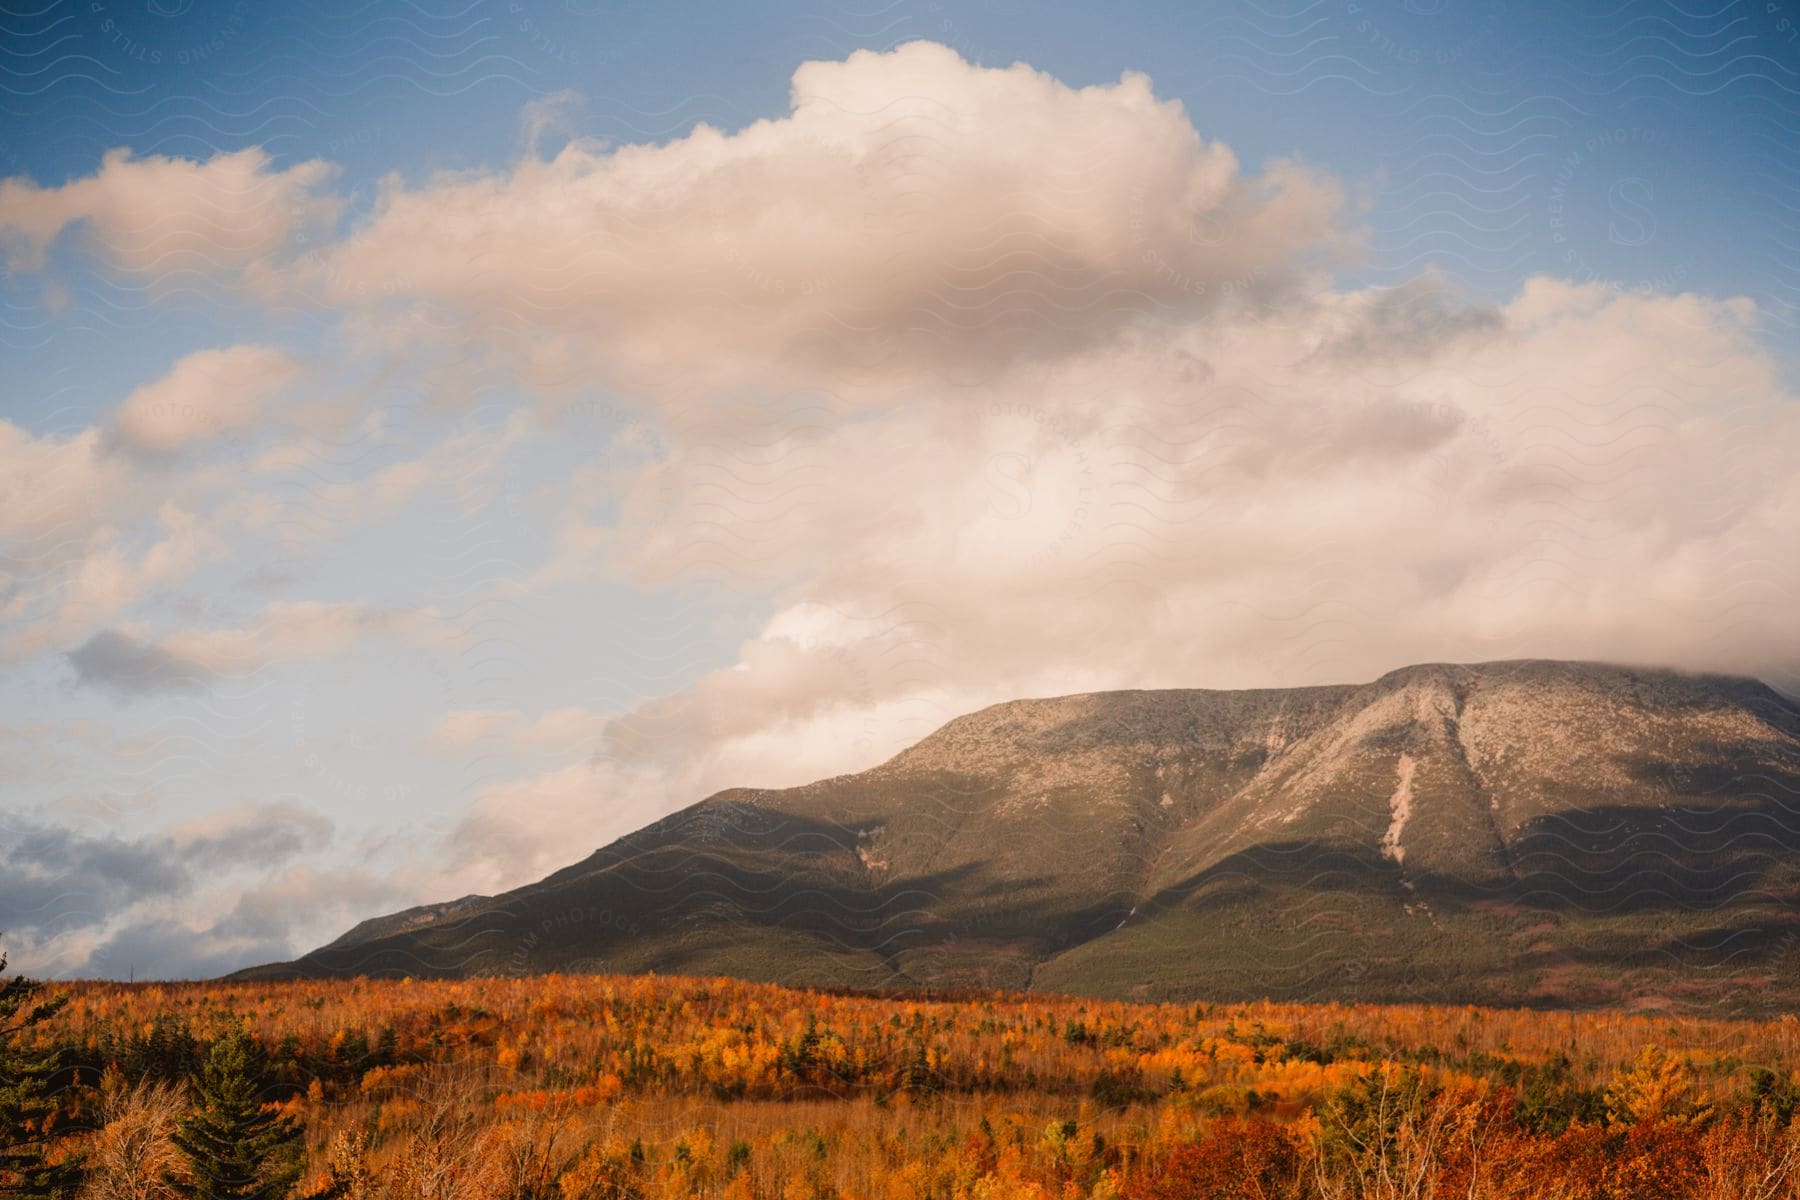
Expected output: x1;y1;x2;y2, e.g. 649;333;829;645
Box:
0;0;1800;979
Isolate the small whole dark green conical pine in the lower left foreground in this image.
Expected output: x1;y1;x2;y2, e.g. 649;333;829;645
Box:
169;1029;304;1200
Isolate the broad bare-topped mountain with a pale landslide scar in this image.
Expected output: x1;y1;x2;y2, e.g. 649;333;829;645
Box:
245;662;1800;1011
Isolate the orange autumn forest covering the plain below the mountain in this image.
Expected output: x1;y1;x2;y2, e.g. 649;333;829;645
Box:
0;975;1800;1200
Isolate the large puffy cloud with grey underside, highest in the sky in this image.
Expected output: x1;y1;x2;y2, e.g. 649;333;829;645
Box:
315;41;1350;401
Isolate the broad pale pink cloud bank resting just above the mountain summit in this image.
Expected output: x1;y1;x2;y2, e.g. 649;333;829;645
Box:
612;281;1800;694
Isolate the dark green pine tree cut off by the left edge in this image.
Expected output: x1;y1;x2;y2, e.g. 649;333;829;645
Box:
0;950;79;1196
